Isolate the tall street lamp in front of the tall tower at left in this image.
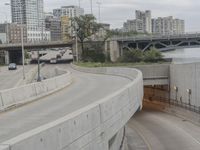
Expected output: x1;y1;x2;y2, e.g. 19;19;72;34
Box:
5;3;26;80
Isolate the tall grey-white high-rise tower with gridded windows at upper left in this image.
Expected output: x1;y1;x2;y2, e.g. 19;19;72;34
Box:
11;0;50;42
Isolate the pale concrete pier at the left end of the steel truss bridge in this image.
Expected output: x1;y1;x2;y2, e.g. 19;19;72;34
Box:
110;41;120;62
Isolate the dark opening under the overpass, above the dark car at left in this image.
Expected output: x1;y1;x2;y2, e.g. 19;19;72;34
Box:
9;51;22;64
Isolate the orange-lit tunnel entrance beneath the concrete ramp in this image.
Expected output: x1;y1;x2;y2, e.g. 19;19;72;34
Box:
144;85;170;103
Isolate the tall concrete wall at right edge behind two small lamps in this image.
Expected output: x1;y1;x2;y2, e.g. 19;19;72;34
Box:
170;63;200;107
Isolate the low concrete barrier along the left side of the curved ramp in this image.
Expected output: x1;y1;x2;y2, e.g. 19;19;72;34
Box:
0;68;72;111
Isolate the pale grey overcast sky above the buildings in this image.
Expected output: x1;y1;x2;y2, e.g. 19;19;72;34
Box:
0;0;200;31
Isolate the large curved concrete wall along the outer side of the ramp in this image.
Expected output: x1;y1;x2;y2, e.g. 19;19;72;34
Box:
0;66;143;150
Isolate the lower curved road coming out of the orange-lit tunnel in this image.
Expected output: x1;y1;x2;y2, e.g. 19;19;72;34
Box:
128;104;200;150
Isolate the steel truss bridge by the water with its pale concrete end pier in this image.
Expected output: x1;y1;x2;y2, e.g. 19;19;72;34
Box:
110;33;200;61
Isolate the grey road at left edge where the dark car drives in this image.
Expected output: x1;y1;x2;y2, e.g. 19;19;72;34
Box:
0;65;34;90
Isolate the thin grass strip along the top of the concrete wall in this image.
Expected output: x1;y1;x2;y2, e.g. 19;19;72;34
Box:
74;61;170;67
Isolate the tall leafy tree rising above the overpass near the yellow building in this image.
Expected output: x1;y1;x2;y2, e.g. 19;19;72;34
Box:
72;14;101;54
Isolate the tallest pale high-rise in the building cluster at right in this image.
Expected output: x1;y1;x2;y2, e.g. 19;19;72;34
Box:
135;10;152;33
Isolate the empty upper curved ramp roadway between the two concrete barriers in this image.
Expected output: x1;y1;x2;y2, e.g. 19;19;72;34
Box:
0;65;130;142
